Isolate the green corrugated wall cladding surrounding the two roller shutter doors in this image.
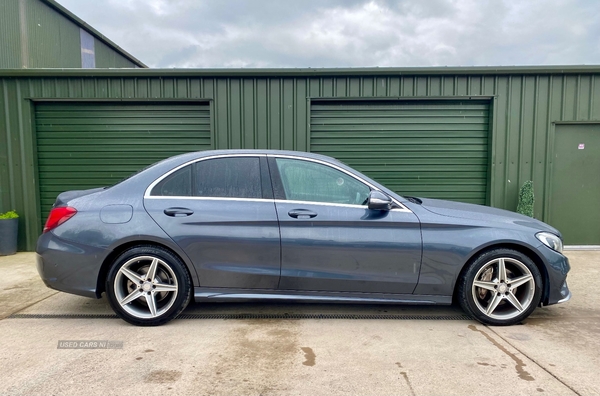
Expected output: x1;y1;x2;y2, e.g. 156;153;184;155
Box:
0;67;600;249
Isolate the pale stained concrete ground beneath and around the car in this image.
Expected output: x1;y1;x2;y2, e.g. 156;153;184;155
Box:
0;251;600;396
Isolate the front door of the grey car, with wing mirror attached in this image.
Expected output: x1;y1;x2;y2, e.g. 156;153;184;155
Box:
269;157;421;294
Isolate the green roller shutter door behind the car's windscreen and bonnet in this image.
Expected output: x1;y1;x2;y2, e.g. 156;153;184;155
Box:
310;100;489;204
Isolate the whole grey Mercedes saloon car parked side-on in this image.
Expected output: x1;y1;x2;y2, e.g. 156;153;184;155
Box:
37;150;571;326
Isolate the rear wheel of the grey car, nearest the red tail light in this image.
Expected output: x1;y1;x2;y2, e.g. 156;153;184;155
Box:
106;246;192;326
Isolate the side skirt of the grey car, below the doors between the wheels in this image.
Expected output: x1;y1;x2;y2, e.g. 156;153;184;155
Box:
194;287;452;305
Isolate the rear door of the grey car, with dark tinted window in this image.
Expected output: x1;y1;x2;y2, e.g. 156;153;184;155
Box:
144;155;280;289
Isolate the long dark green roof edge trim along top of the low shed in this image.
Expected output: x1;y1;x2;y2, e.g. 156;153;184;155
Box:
0;64;600;77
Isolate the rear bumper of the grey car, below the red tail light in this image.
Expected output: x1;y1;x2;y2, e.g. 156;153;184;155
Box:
36;232;108;298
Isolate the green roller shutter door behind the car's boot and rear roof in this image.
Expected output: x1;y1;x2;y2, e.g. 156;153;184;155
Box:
35;102;211;220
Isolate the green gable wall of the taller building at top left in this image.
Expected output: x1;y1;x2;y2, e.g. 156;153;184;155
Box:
0;0;136;69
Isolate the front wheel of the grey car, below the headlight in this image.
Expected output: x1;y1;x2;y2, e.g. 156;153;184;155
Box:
457;249;542;326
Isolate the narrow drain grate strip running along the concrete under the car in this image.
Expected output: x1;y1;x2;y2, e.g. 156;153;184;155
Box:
8;313;471;320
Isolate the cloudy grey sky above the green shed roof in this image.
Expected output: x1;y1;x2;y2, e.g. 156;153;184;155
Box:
58;0;600;67
